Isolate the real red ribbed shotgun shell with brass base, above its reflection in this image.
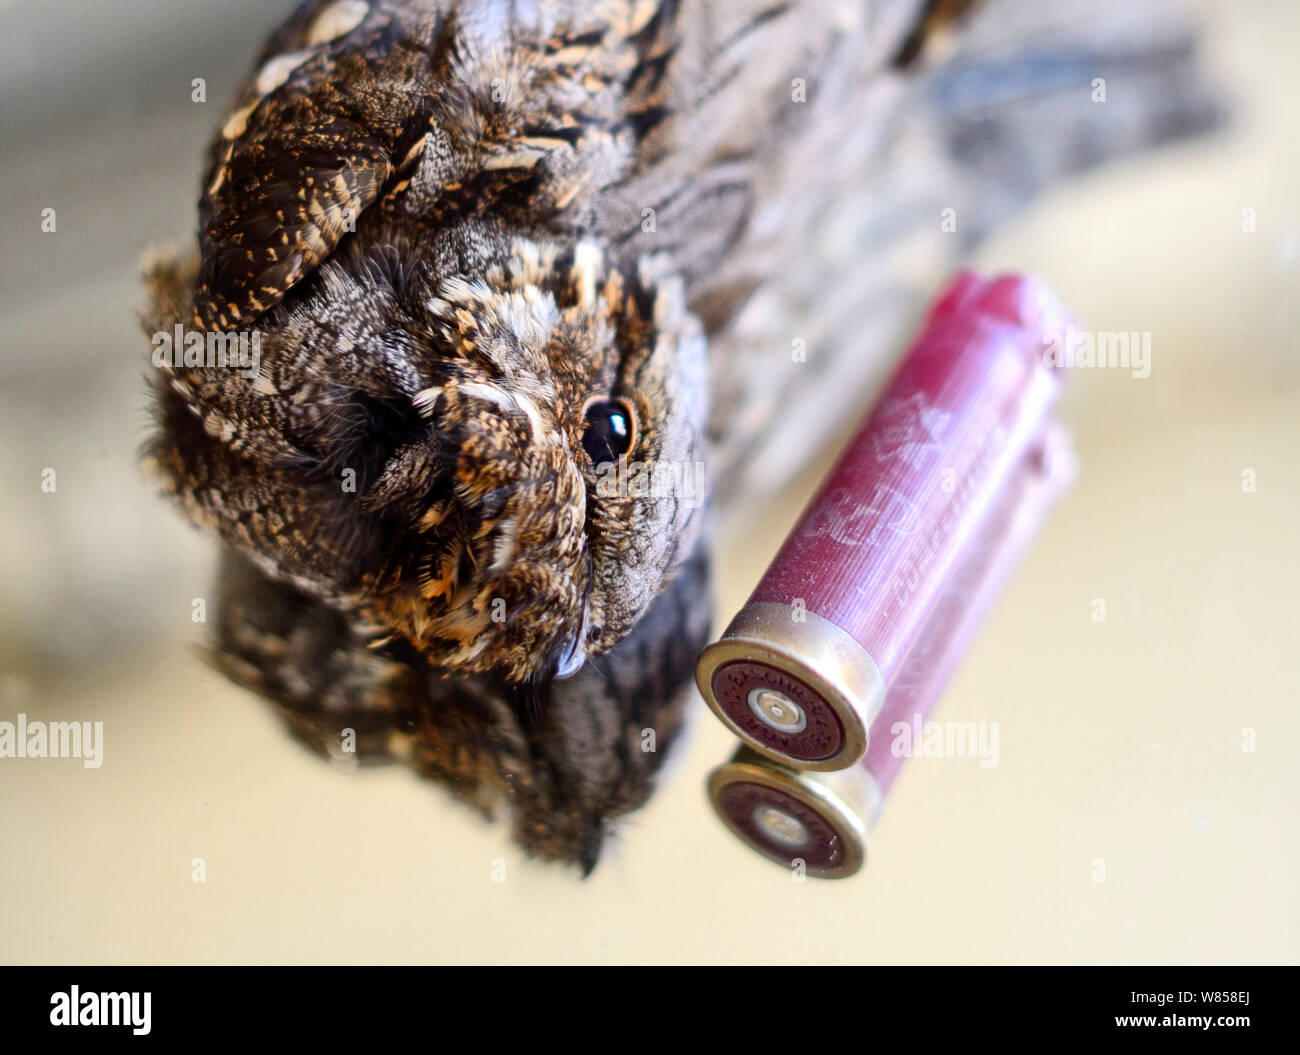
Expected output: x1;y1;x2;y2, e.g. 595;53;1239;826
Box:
696;272;1069;769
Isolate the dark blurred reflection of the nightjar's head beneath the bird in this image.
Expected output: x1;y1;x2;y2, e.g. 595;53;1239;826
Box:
213;546;710;871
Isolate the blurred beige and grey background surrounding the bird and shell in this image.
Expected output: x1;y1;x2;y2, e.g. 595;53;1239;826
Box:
0;0;1300;963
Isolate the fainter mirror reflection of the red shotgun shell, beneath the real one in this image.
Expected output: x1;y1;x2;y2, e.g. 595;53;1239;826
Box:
709;425;1075;878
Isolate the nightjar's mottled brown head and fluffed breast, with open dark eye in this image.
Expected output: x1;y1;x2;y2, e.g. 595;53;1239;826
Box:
152;225;707;682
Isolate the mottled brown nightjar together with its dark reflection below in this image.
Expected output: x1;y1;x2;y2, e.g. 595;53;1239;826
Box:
143;0;1216;867
